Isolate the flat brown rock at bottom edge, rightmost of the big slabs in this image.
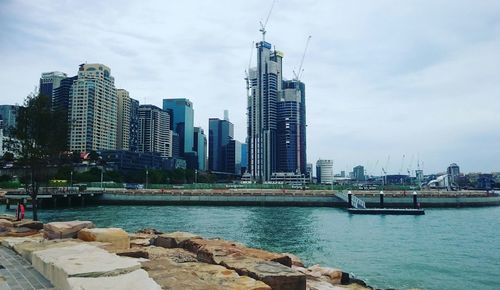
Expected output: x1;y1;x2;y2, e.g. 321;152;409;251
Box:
218;254;306;290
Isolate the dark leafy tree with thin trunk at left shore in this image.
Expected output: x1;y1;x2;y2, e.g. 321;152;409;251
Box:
14;93;67;220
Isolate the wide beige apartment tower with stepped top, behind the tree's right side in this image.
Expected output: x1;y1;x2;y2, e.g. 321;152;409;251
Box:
69;64;118;152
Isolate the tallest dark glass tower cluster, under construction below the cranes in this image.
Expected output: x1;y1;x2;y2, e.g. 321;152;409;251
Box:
246;41;307;182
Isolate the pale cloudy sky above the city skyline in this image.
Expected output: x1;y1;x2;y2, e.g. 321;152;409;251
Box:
0;0;500;175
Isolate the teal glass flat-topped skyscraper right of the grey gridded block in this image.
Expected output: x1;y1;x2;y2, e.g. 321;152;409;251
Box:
163;98;194;160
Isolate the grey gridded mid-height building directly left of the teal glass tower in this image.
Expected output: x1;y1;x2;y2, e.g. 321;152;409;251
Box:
138;105;172;157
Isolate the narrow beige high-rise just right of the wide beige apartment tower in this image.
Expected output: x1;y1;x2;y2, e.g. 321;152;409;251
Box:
116;89;131;150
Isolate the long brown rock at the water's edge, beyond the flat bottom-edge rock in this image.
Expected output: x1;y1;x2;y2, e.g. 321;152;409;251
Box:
182;239;292;267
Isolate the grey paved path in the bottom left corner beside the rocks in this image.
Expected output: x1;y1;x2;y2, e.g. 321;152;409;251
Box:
0;246;55;290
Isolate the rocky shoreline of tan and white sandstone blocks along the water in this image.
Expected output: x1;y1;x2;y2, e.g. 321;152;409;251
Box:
0;215;372;290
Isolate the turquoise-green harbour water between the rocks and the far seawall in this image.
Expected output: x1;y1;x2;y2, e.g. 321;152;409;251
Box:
0;206;500;289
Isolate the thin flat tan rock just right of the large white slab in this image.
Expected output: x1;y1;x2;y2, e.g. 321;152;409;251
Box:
116;246;198;263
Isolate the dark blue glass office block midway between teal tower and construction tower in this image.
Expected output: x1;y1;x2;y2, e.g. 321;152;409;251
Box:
208;114;236;172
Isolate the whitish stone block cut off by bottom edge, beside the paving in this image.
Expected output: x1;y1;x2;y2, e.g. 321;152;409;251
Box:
68;270;161;290
